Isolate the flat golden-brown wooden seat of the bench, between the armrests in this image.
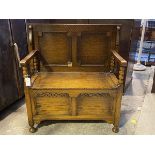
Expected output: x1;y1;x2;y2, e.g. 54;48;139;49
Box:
32;72;119;89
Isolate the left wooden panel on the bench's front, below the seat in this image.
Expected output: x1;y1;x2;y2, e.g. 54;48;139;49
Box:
35;94;70;115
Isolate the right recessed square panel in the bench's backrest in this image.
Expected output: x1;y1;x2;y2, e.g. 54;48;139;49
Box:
78;33;110;66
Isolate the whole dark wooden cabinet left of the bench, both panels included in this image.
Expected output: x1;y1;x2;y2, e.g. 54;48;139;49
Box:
0;19;27;111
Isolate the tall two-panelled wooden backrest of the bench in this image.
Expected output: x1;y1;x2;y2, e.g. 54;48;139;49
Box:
27;24;117;72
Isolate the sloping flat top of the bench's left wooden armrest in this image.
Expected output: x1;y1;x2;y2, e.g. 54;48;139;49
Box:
20;50;39;66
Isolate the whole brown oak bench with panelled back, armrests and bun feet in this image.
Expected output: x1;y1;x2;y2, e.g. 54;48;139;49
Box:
20;24;127;132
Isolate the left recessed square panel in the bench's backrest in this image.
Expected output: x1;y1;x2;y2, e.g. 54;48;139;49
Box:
38;32;71;65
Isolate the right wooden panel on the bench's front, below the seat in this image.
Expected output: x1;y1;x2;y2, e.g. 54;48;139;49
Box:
77;93;114;116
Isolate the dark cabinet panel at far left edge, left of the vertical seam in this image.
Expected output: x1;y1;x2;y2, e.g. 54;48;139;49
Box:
0;19;19;111
